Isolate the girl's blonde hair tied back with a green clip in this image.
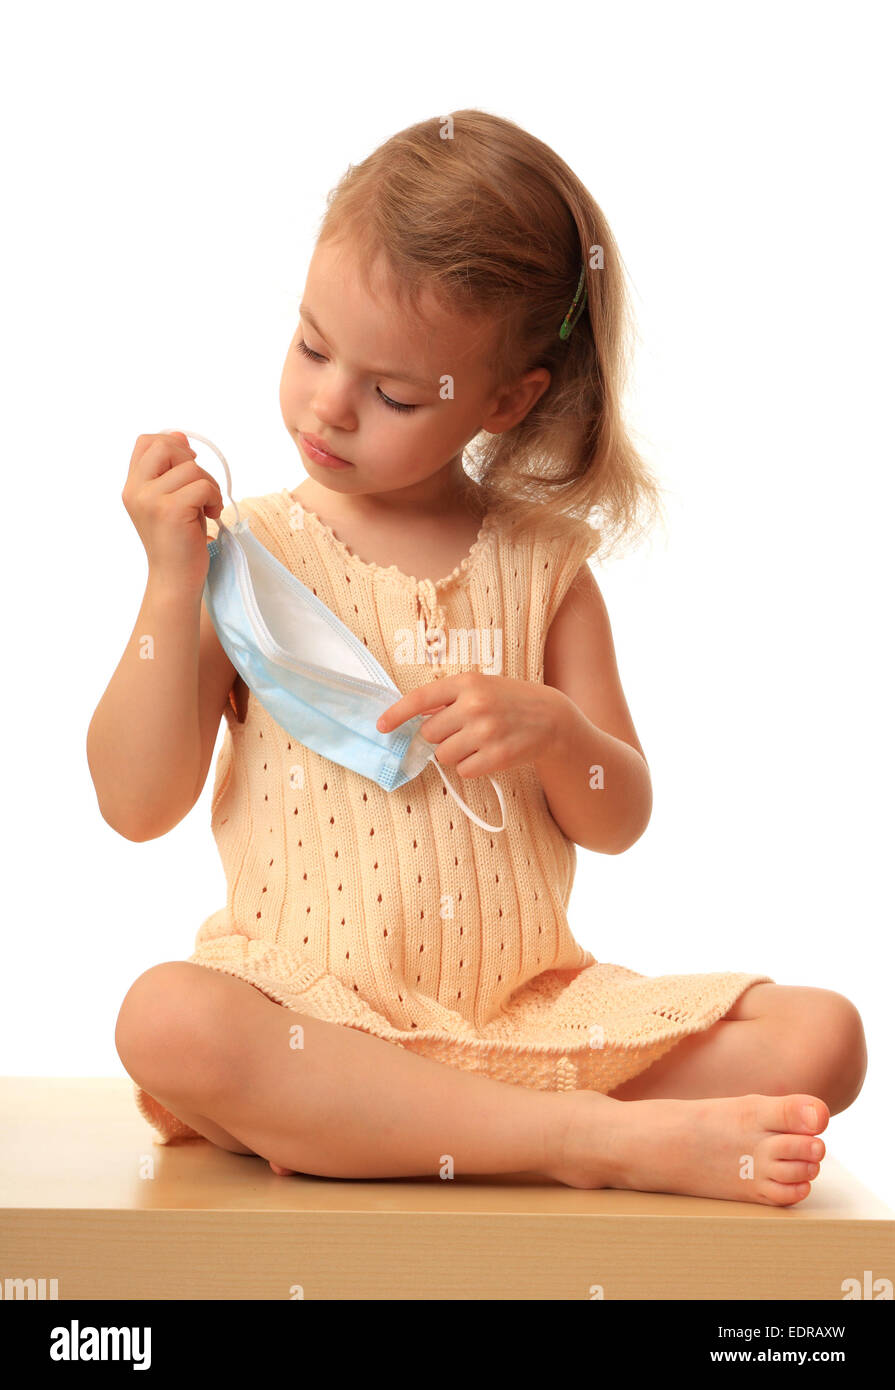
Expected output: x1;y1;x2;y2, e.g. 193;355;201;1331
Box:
318;108;662;557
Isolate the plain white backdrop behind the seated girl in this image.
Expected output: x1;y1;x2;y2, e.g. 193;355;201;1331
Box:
0;0;895;1202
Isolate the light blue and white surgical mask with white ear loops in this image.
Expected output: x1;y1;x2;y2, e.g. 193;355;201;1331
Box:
165;430;506;831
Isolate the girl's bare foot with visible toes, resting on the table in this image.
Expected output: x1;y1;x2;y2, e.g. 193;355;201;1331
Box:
549;1091;830;1207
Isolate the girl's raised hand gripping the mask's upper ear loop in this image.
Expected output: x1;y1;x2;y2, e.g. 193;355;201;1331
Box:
121;430;224;592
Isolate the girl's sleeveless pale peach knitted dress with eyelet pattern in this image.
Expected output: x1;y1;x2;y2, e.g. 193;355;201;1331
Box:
135;488;770;1144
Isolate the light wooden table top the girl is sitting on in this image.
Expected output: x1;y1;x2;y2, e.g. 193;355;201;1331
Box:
0;1076;895;1300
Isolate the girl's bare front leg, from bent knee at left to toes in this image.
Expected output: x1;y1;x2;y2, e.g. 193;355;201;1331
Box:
115;962;830;1205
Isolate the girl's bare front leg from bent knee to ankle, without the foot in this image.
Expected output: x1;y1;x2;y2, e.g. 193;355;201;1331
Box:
115;962;564;1177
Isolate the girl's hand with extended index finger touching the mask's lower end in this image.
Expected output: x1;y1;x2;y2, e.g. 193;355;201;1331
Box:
377;671;563;777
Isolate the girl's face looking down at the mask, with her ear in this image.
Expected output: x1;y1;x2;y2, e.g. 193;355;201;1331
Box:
279;243;550;502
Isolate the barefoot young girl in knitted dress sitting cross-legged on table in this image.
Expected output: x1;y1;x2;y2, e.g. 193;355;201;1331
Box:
88;110;866;1205
